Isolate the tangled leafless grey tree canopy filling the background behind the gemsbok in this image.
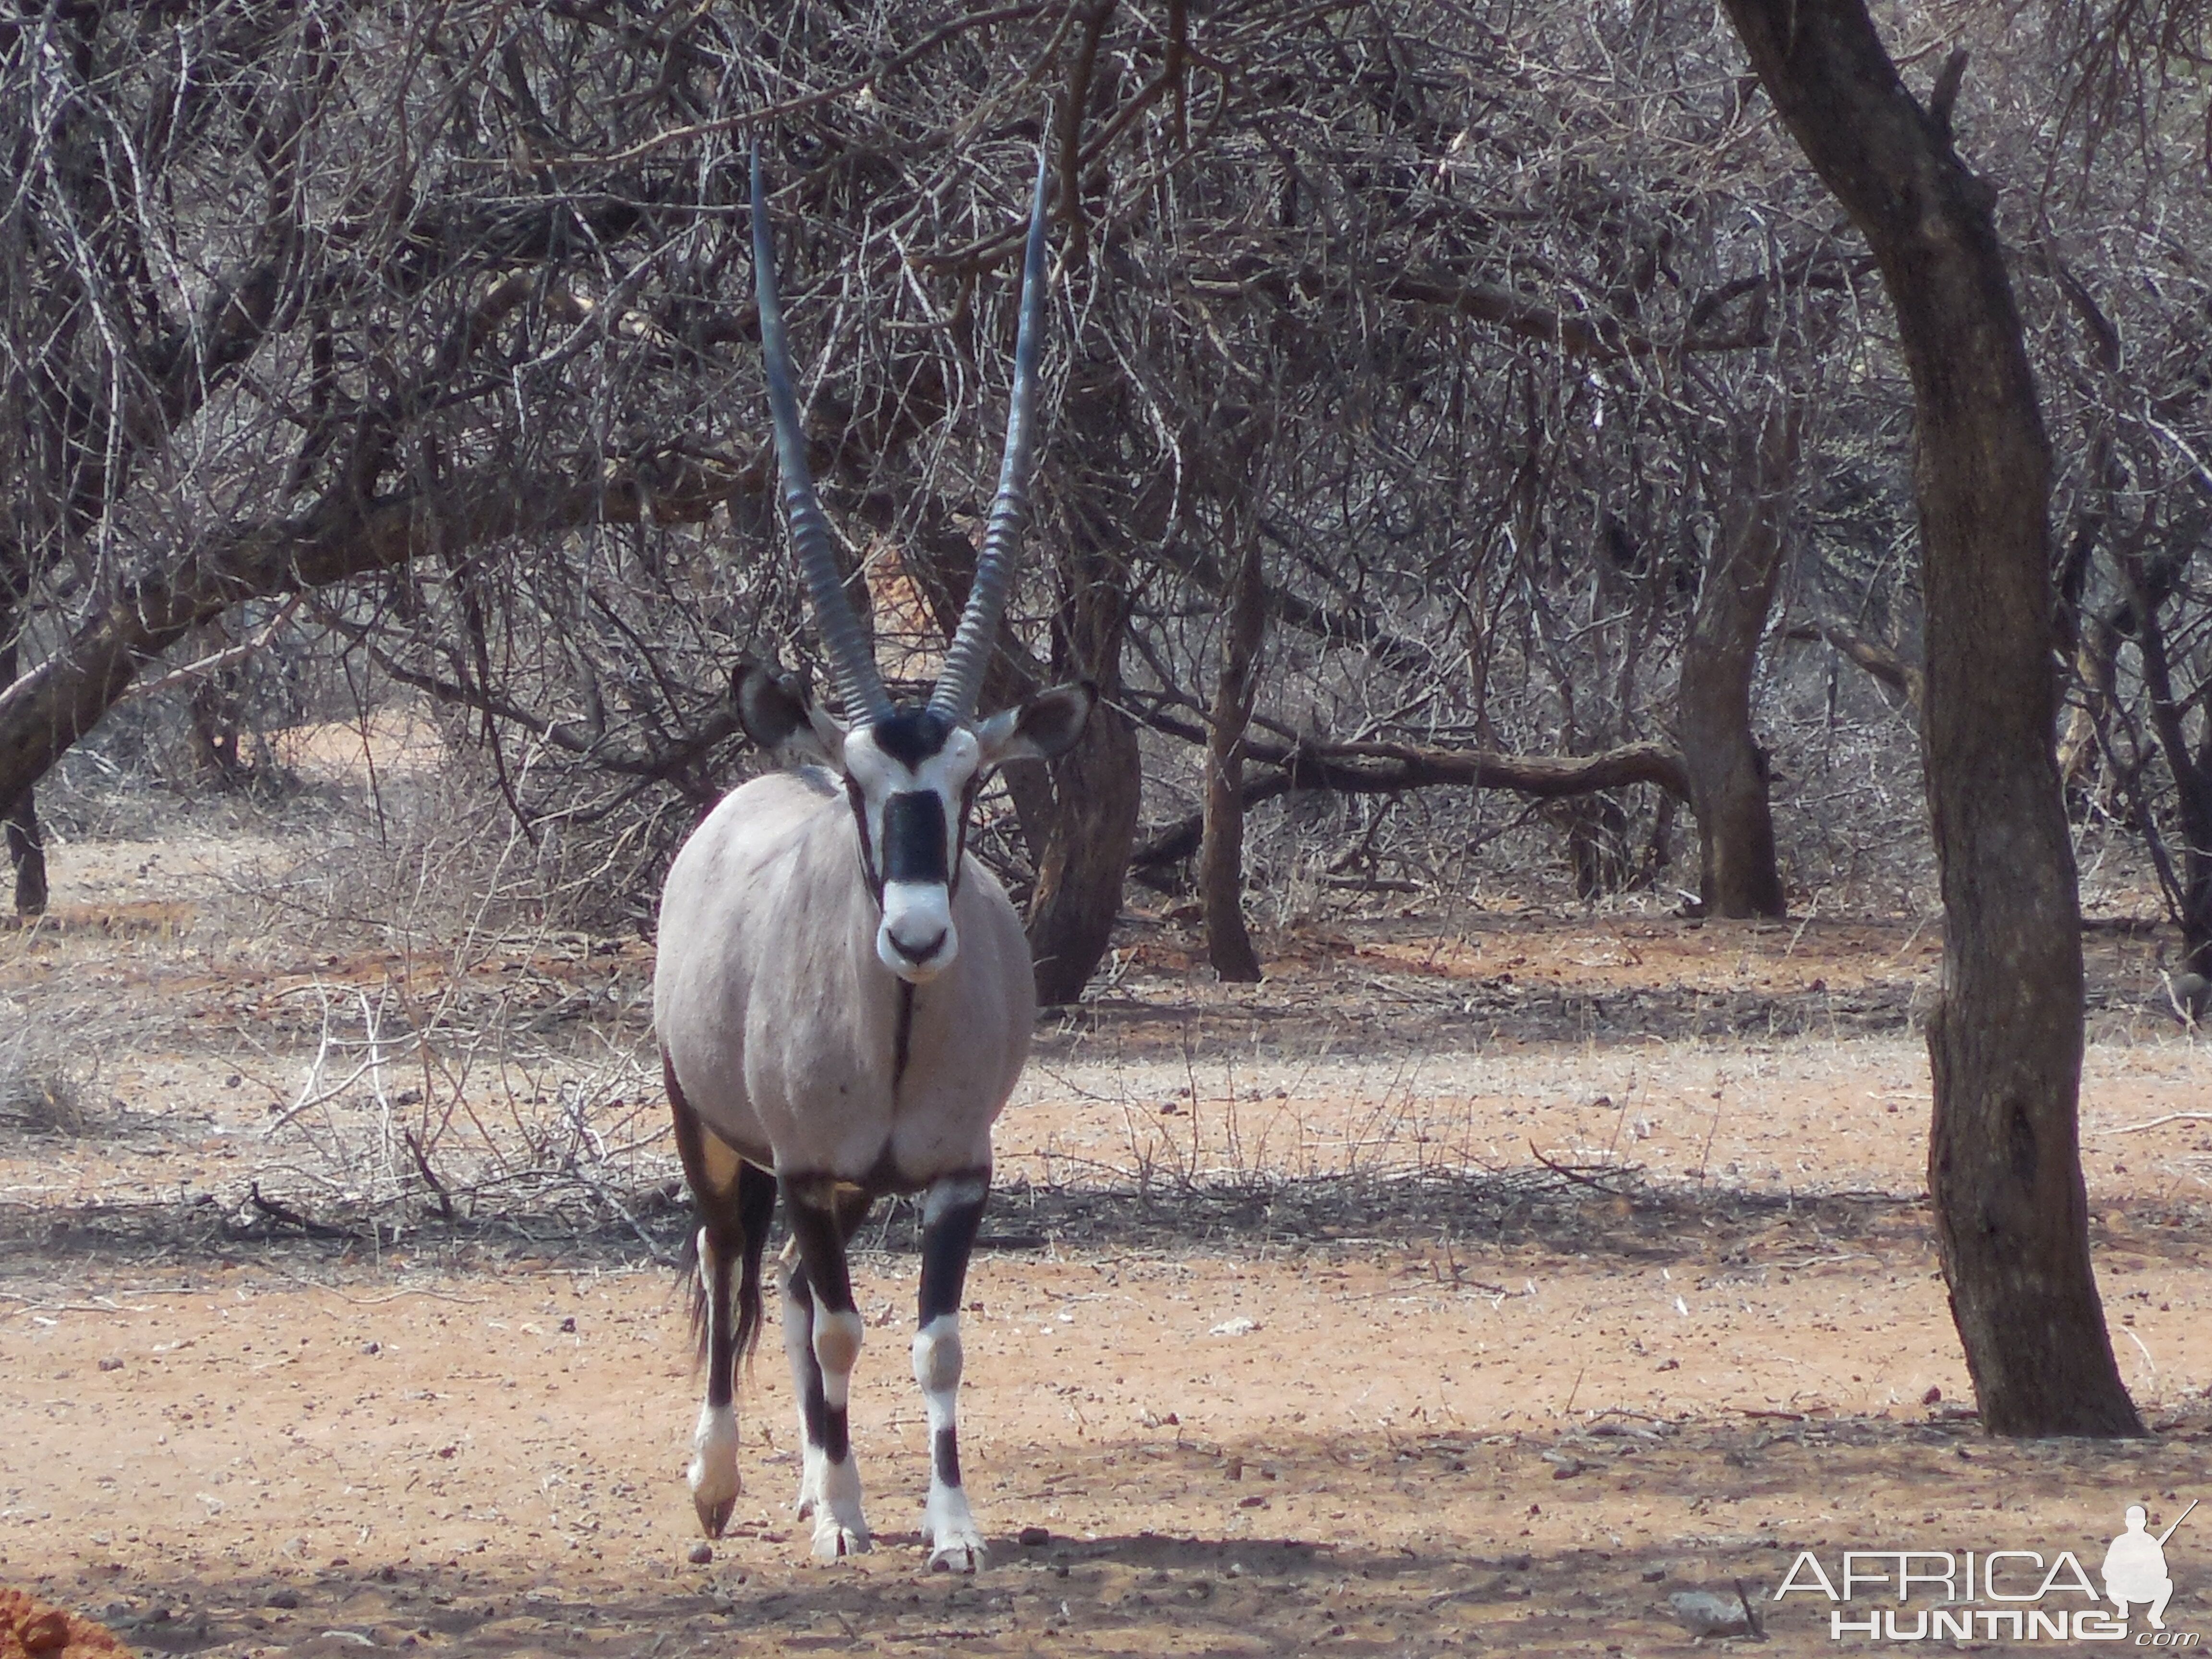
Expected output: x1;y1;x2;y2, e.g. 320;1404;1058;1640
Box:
0;0;2212;955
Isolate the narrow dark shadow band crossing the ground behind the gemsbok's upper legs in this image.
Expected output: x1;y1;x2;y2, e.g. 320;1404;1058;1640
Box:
0;1166;2212;1283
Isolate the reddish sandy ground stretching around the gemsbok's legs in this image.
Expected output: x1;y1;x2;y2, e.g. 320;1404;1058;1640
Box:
0;801;2212;1655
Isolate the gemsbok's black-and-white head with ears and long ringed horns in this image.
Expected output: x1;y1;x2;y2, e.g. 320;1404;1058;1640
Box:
734;150;1095;985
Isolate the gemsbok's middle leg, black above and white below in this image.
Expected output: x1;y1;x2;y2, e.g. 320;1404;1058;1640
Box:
783;1177;869;1562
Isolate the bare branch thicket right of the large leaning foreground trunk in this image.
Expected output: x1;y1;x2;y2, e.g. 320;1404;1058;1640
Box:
1969;4;2212;947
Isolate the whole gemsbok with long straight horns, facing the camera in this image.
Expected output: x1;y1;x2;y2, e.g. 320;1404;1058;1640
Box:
652;155;1093;1573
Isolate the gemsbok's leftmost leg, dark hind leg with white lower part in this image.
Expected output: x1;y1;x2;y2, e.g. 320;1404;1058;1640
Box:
668;1077;776;1538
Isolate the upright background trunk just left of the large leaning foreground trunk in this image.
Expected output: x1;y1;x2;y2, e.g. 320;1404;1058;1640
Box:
1681;398;1798;916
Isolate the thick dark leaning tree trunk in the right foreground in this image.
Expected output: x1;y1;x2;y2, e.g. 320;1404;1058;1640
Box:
1728;0;2141;1436
